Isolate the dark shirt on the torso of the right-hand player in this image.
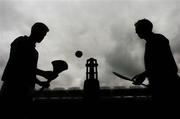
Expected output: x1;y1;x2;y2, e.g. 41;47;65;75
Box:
145;34;177;75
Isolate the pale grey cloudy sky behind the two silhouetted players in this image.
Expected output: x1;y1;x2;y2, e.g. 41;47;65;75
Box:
0;0;180;88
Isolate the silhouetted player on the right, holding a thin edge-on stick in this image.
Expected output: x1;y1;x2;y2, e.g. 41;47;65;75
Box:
134;19;179;105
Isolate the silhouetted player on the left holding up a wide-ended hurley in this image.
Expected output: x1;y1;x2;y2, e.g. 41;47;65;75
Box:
1;22;57;119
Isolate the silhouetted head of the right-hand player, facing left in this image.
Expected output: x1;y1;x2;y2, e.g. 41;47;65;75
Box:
134;19;153;39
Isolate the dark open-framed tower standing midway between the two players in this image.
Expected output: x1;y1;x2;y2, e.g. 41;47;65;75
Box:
84;58;100;100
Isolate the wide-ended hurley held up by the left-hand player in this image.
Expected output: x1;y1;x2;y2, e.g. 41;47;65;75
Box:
39;60;68;92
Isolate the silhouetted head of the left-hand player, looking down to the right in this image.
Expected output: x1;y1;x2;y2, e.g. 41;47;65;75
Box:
30;22;49;43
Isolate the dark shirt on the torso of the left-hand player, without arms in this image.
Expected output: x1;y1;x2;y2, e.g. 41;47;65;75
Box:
2;36;38;95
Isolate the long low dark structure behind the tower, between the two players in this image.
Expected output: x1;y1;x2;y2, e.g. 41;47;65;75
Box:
35;87;151;103
